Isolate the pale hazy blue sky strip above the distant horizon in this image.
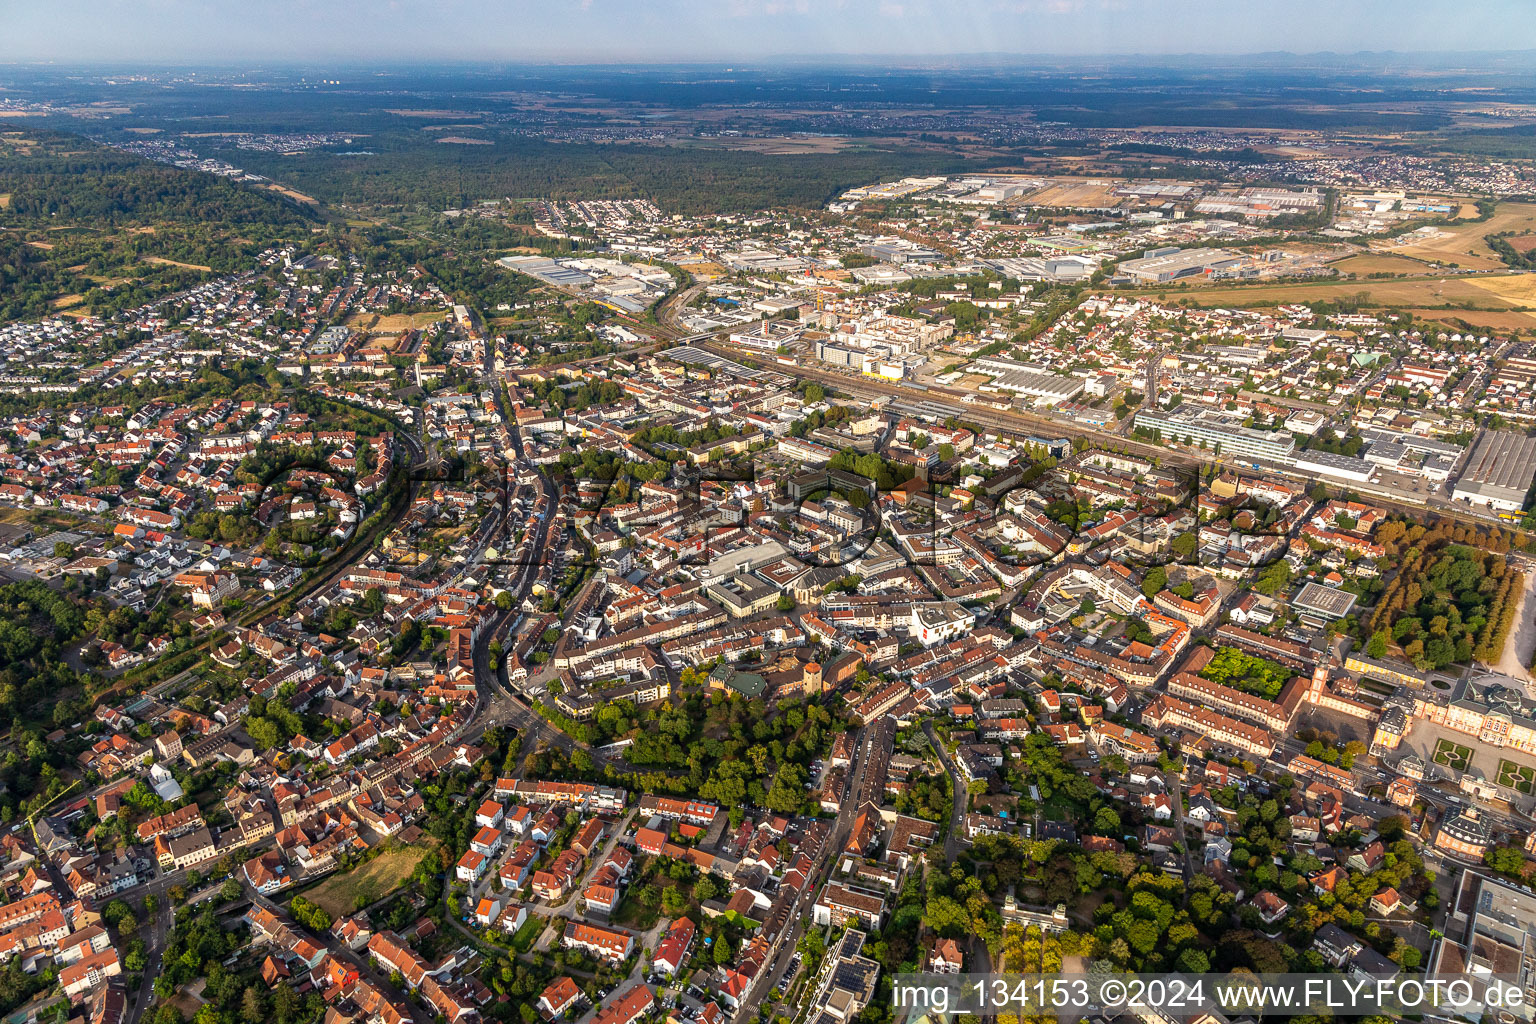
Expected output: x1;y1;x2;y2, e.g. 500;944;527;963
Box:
0;0;1536;64
